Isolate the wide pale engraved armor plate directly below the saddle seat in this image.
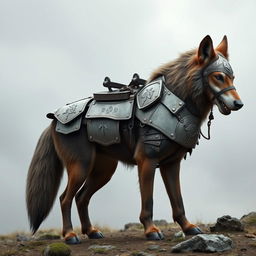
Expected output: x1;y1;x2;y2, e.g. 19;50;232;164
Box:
86;99;134;120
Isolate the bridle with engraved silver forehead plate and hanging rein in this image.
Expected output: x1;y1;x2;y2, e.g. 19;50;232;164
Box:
200;54;236;140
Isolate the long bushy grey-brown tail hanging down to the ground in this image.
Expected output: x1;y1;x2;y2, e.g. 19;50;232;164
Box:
26;127;63;233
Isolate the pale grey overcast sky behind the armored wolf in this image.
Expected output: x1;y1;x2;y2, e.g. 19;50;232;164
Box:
0;0;256;234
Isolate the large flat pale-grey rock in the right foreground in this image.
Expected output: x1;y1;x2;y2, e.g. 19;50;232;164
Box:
171;234;232;253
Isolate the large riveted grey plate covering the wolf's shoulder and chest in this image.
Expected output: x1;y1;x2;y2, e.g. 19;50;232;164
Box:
135;82;201;148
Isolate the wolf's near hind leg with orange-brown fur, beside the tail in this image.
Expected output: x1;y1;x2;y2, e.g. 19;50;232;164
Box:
53;129;95;244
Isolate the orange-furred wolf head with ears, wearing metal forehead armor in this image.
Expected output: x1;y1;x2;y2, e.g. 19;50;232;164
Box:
197;36;243;115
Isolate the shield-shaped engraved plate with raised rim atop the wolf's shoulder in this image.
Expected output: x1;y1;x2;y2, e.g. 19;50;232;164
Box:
137;79;163;109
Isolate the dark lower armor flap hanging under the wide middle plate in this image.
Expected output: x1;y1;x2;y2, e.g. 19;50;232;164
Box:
87;118;120;146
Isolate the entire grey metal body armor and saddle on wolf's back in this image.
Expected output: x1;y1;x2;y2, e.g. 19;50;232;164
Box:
47;74;201;149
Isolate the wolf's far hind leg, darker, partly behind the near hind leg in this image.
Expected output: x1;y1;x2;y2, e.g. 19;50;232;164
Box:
76;154;118;239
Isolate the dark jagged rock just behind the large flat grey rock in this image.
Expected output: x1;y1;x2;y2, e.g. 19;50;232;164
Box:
210;215;244;232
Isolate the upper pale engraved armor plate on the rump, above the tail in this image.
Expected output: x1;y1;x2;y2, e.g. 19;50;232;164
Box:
54;98;92;124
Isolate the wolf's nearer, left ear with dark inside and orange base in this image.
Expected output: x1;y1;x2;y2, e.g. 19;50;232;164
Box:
197;35;216;64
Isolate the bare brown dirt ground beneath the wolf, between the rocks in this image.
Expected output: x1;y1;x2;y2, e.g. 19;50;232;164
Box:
0;225;256;256
